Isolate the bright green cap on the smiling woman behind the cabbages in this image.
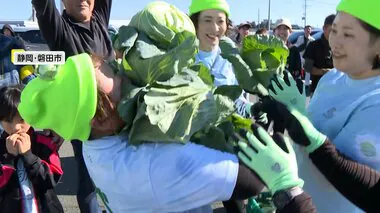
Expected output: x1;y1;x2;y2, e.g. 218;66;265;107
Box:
190;0;231;17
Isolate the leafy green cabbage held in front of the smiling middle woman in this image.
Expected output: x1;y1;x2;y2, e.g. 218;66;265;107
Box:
220;35;289;95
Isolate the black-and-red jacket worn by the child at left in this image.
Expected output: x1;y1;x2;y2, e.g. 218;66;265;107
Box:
0;128;63;213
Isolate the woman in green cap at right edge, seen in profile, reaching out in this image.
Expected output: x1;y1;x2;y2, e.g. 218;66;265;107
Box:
252;0;380;213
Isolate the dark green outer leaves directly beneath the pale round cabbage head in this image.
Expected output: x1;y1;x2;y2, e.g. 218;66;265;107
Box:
123;31;198;87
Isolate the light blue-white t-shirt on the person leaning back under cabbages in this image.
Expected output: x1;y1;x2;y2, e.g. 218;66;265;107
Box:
83;136;239;213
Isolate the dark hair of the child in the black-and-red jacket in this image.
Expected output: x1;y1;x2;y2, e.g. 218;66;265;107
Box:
0;85;22;122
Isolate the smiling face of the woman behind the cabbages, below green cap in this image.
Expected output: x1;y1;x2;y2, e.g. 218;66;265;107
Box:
197;10;227;51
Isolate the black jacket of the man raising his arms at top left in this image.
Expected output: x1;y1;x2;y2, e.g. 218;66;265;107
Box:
32;0;113;59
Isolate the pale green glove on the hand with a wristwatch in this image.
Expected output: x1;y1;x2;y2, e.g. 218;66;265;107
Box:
238;125;303;194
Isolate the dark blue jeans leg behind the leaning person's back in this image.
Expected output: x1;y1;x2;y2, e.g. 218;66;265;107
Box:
71;140;102;213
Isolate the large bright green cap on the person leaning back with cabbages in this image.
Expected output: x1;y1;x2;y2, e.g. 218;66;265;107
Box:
18;53;97;141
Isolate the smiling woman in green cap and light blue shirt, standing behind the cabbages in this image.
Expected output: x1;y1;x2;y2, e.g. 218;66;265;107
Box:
190;0;251;117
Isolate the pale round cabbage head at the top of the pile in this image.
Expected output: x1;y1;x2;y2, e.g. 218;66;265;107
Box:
129;1;195;49
